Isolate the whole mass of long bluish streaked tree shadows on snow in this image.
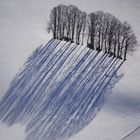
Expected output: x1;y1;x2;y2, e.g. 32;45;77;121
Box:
0;39;123;140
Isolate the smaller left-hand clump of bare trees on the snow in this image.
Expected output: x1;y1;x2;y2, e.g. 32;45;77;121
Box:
48;5;87;44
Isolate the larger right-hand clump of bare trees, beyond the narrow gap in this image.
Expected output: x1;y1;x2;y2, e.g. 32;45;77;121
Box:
87;11;137;59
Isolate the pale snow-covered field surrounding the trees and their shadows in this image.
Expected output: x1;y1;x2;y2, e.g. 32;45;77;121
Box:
0;0;140;140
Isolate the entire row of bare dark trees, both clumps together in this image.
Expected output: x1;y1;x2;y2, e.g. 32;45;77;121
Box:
48;5;137;60
